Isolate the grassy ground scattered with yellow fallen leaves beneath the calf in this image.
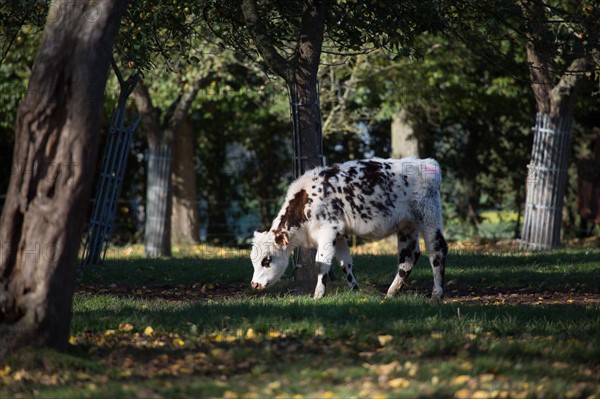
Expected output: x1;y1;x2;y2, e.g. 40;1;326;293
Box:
0;249;600;398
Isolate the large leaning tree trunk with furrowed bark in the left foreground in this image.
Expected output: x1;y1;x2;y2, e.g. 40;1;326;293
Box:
0;0;127;355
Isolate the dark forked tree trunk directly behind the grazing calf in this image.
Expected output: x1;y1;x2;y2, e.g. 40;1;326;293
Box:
242;0;326;291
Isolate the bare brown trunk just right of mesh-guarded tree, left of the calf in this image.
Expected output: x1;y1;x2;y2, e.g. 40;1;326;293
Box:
171;119;200;246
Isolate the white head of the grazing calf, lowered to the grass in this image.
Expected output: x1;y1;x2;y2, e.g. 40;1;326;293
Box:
250;229;289;289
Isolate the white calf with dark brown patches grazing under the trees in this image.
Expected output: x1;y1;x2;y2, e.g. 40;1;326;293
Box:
251;158;448;298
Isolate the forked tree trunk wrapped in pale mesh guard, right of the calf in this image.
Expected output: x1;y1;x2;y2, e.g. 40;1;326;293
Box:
520;0;598;250
